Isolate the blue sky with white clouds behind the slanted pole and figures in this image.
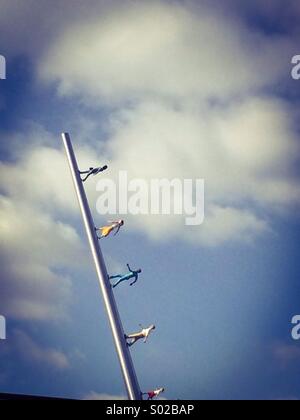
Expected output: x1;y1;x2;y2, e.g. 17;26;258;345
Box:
0;0;300;400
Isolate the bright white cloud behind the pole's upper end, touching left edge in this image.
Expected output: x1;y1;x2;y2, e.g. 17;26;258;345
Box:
0;126;98;215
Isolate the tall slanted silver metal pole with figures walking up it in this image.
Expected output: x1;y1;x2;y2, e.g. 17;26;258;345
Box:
62;133;142;400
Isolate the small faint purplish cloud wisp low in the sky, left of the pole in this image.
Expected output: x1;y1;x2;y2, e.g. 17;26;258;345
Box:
13;330;70;371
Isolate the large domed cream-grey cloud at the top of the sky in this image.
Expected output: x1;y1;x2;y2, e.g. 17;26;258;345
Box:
40;1;290;104
